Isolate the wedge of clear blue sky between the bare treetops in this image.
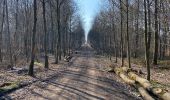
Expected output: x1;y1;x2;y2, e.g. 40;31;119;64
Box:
74;0;101;41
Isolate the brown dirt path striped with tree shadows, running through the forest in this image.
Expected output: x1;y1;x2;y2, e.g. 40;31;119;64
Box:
1;50;139;100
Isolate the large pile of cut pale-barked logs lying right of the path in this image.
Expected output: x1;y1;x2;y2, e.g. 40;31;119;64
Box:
108;67;170;100
